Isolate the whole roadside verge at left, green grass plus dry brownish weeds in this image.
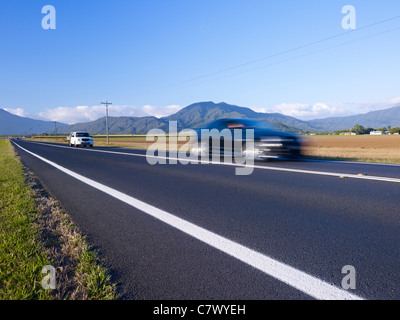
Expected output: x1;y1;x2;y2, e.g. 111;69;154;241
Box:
0;140;117;300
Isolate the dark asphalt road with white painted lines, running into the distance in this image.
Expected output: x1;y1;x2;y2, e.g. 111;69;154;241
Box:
10;140;400;300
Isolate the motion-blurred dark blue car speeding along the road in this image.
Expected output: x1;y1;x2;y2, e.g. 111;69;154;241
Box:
192;118;301;160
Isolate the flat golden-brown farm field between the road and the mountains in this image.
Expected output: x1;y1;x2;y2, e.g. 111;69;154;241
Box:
25;135;400;164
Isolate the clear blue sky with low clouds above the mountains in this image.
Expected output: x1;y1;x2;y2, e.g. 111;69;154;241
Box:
0;0;400;123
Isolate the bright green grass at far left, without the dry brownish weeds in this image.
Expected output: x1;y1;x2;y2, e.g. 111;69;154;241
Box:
0;140;50;300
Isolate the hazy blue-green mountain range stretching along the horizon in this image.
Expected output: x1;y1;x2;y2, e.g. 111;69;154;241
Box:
0;102;400;135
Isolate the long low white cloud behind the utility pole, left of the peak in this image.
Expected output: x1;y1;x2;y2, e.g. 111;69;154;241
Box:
39;105;181;124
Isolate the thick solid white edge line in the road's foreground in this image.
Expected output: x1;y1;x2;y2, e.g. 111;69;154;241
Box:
14;142;363;300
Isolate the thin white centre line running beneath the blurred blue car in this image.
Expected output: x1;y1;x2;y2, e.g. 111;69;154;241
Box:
20;141;400;183
